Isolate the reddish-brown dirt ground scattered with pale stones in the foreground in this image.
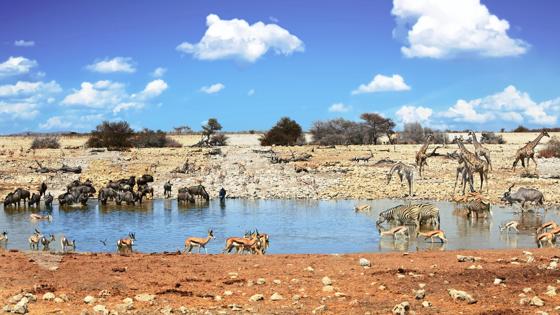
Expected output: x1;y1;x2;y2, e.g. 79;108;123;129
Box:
0;249;560;314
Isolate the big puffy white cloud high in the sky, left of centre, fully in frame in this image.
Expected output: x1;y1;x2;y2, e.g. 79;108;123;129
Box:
177;14;304;62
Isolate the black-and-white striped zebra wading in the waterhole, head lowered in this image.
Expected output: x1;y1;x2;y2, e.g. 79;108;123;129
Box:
376;204;440;229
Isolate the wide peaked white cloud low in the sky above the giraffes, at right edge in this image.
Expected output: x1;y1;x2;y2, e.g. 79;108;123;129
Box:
441;85;560;126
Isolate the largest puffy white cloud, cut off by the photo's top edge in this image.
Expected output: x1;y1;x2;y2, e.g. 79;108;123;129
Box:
391;0;529;58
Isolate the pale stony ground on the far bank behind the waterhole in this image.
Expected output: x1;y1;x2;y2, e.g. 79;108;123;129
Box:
0;134;560;205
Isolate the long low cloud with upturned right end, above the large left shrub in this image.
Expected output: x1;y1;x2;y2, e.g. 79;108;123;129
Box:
61;79;168;114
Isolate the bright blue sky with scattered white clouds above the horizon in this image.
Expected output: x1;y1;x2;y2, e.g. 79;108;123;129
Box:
0;0;560;133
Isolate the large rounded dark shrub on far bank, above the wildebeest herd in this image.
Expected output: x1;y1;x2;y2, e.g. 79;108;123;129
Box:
86;121;134;150
